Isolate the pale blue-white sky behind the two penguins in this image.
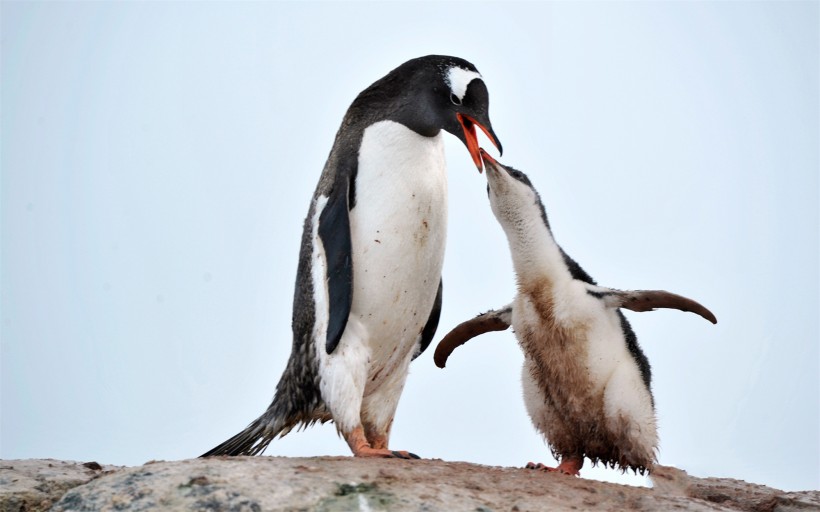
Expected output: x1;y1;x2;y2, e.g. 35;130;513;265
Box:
0;1;820;490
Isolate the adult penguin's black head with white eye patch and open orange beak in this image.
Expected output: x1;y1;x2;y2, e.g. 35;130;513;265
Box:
354;55;501;171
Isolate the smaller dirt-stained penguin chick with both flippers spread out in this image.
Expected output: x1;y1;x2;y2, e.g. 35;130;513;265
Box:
435;150;717;475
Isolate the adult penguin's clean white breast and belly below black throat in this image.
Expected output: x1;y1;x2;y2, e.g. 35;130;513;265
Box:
350;121;447;382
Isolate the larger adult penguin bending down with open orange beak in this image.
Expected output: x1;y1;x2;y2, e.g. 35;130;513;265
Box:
203;55;501;458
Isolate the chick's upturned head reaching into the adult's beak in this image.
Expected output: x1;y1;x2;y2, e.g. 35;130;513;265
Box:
479;148;550;231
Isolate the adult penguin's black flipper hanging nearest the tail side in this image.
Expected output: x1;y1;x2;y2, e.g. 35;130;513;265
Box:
318;178;353;354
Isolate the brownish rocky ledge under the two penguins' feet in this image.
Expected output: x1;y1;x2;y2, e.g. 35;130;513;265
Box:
0;457;820;512
